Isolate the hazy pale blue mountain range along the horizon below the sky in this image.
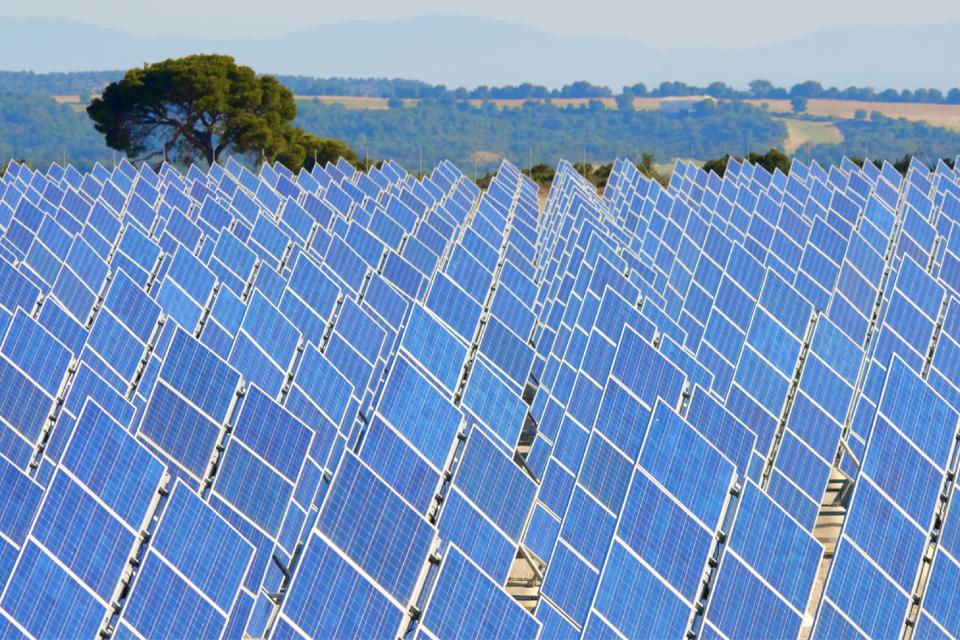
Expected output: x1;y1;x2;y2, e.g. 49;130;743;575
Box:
0;15;960;91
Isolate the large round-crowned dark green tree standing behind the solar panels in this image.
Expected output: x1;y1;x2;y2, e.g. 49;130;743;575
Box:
87;55;305;167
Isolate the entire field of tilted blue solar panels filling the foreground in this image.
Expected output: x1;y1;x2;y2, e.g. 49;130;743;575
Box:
0;149;960;639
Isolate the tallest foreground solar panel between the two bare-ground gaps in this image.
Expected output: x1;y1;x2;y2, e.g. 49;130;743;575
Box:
593;401;734;635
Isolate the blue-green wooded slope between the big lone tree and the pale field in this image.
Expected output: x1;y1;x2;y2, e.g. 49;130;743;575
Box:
295;100;786;171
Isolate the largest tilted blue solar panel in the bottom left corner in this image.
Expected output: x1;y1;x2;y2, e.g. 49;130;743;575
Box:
2;402;164;634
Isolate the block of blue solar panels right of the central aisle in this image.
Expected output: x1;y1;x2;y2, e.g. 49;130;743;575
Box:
525;152;960;638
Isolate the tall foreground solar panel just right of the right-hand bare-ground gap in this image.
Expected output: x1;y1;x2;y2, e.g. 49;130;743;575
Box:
818;358;958;635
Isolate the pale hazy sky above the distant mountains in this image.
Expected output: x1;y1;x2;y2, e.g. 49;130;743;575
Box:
7;0;960;48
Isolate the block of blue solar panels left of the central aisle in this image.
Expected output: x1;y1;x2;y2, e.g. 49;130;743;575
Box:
0;152;556;637
